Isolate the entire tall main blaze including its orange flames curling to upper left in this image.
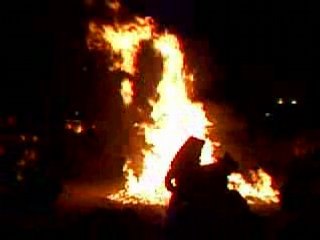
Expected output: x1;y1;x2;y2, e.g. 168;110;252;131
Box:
88;7;280;205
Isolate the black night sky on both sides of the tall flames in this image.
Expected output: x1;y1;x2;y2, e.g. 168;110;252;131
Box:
0;0;319;124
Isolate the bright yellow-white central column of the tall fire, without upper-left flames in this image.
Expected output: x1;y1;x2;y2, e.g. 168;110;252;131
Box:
117;34;213;204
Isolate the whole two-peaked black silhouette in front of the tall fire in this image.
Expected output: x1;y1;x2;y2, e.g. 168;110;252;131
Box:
165;137;250;239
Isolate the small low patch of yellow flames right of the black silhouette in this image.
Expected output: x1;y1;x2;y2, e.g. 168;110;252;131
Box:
228;169;280;204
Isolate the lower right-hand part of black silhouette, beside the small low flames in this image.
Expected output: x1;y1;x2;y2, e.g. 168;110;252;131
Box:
192;153;253;239
